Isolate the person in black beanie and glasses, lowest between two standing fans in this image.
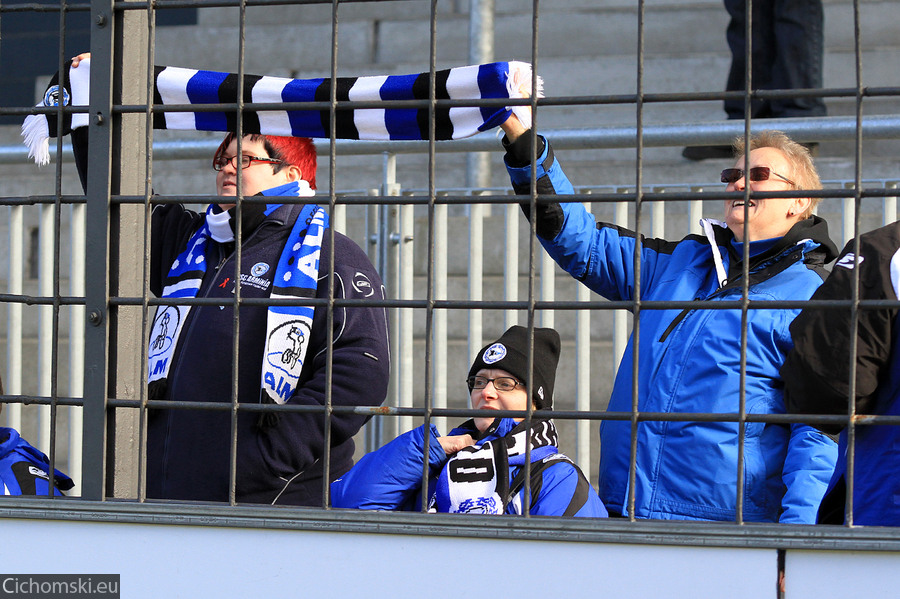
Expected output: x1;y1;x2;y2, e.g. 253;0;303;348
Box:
331;326;607;517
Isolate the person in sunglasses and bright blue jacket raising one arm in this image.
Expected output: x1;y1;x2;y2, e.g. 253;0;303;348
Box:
503;117;837;523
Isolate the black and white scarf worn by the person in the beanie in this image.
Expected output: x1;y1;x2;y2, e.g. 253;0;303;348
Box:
431;418;560;514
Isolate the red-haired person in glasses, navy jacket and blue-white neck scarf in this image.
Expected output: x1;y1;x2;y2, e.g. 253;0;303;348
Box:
73;55;390;506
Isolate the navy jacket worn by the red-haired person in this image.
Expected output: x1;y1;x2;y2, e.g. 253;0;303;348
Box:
147;204;390;506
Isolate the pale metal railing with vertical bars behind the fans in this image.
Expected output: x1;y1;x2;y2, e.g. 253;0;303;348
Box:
0;127;900;493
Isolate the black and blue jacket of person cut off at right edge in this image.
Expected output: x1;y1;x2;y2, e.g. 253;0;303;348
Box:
781;223;900;526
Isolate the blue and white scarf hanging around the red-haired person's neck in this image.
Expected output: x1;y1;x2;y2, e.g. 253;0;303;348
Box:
148;181;328;404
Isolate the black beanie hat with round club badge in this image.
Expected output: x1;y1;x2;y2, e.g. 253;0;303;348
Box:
469;325;560;410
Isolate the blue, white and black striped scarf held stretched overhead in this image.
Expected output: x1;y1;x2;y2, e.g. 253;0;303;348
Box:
22;59;543;165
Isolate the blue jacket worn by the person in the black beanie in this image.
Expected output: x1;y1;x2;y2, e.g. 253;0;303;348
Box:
331;418;607;518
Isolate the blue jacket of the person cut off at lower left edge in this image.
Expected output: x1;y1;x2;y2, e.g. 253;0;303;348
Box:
0;380;75;497
